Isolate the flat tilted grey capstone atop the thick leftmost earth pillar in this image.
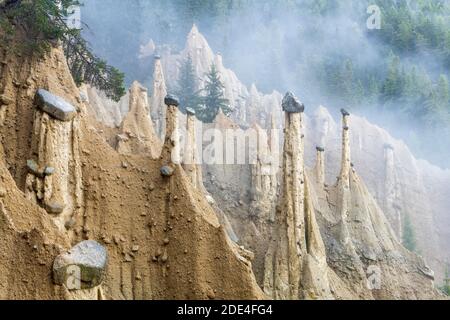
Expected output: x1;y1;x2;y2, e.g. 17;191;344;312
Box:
36;89;77;121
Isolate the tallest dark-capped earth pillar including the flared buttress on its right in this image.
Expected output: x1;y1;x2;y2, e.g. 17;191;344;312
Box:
264;93;331;300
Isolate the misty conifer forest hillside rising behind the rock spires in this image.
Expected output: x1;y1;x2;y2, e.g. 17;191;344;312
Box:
82;0;450;167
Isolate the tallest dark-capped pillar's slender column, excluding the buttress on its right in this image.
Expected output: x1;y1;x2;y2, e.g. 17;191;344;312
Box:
264;93;306;299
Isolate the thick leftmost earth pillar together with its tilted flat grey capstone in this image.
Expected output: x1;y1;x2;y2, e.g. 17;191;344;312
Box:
26;89;83;230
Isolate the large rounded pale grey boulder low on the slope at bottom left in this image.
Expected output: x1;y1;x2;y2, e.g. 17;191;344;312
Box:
53;240;108;290
